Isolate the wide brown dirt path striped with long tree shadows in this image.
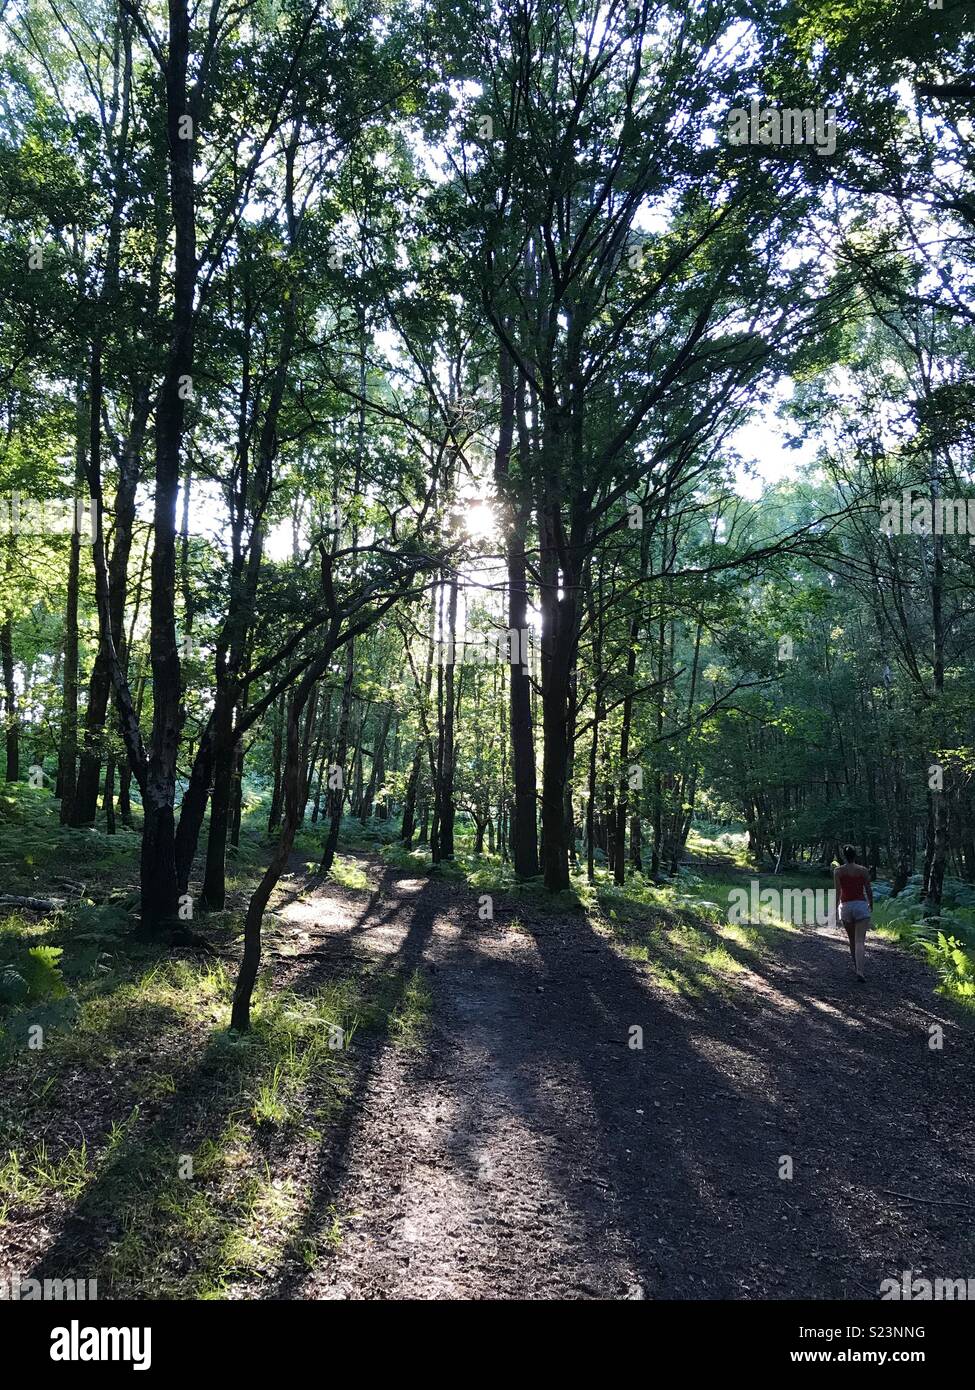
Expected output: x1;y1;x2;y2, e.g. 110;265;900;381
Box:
268;860;975;1298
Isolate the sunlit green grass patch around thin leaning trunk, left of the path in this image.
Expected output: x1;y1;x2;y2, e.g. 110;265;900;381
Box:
0;927;431;1298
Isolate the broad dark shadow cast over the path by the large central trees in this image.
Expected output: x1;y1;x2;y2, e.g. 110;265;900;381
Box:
400;878;972;1298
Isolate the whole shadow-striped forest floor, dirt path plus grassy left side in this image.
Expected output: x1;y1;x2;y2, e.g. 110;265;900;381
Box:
0;834;975;1300
